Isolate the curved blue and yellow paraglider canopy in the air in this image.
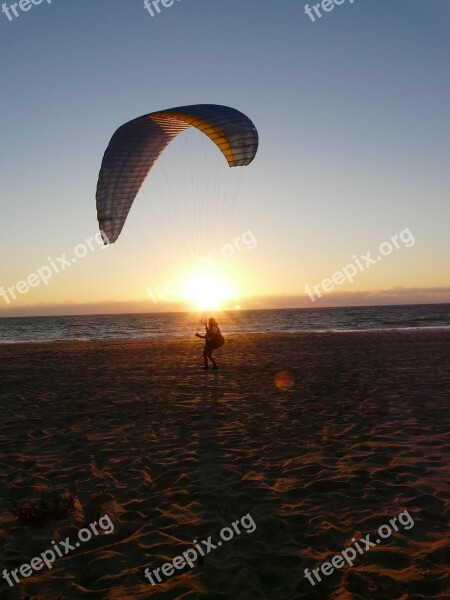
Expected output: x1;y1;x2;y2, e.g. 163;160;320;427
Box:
96;104;258;243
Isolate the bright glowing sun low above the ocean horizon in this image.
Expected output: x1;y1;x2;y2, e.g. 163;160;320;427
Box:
183;273;235;310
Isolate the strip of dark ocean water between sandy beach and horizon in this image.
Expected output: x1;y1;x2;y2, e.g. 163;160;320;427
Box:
0;304;450;344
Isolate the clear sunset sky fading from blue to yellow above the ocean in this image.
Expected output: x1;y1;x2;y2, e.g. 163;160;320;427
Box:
0;0;450;316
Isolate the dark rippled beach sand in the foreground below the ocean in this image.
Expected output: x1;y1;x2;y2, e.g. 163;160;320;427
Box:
0;332;450;600
